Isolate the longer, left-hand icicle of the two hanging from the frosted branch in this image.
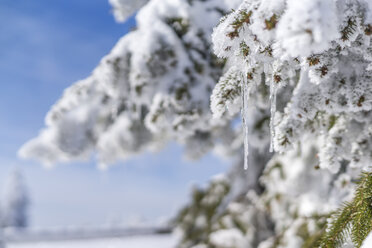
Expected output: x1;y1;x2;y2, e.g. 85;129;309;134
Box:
241;73;249;170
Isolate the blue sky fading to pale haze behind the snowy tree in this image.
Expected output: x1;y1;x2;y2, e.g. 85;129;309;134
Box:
0;0;227;227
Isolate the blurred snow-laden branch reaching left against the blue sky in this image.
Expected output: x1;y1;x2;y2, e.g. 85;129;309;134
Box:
19;0;240;169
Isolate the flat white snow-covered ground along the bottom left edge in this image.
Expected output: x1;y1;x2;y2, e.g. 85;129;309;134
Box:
6;234;177;248
